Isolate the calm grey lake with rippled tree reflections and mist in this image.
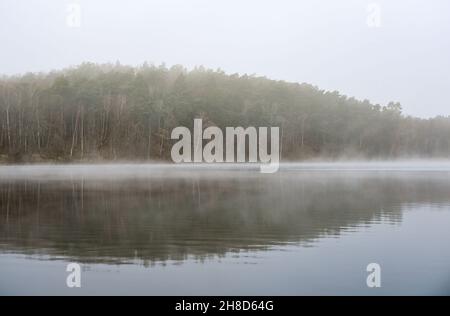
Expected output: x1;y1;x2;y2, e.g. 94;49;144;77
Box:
0;162;450;295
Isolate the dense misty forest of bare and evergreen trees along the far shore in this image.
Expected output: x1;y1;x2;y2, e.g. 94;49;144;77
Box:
0;63;450;161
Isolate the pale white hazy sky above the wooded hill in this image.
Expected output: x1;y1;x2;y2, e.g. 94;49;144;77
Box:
0;0;450;117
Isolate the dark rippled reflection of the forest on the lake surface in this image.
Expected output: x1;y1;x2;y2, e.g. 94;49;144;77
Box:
0;173;450;263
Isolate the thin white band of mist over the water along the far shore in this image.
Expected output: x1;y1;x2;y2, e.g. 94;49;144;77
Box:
0;160;450;181
